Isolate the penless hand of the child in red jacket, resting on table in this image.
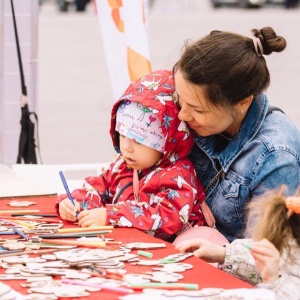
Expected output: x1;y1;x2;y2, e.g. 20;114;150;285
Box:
78;207;106;227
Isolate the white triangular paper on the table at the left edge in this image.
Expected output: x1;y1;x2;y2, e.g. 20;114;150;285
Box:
0;165;57;198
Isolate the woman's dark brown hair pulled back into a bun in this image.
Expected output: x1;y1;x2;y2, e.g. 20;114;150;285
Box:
174;27;286;107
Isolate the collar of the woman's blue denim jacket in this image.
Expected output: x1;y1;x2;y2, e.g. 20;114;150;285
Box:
195;94;268;173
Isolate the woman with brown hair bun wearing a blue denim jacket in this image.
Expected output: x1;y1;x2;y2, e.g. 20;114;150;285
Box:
174;27;300;241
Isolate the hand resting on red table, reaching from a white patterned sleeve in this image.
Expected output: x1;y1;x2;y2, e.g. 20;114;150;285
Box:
176;238;226;264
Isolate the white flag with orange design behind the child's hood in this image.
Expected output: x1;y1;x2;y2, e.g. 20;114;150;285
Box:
96;0;151;101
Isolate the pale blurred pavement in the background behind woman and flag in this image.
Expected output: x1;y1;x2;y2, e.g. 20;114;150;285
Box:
38;0;300;164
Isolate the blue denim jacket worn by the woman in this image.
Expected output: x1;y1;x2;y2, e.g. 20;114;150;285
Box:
190;94;300;241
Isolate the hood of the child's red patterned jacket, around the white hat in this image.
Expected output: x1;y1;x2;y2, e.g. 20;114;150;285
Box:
110;70;194;167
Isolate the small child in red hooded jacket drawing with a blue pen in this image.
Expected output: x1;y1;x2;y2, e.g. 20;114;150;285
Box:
57;71;205;240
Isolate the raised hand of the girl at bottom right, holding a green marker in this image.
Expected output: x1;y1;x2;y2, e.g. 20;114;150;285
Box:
250;239;280;284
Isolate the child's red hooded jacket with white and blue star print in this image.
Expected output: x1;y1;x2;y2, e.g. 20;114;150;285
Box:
58;70;205;240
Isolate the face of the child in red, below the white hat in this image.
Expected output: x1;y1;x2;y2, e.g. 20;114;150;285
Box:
120;135;163;170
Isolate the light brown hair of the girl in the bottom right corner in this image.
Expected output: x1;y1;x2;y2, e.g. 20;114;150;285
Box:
246;186;300;254
